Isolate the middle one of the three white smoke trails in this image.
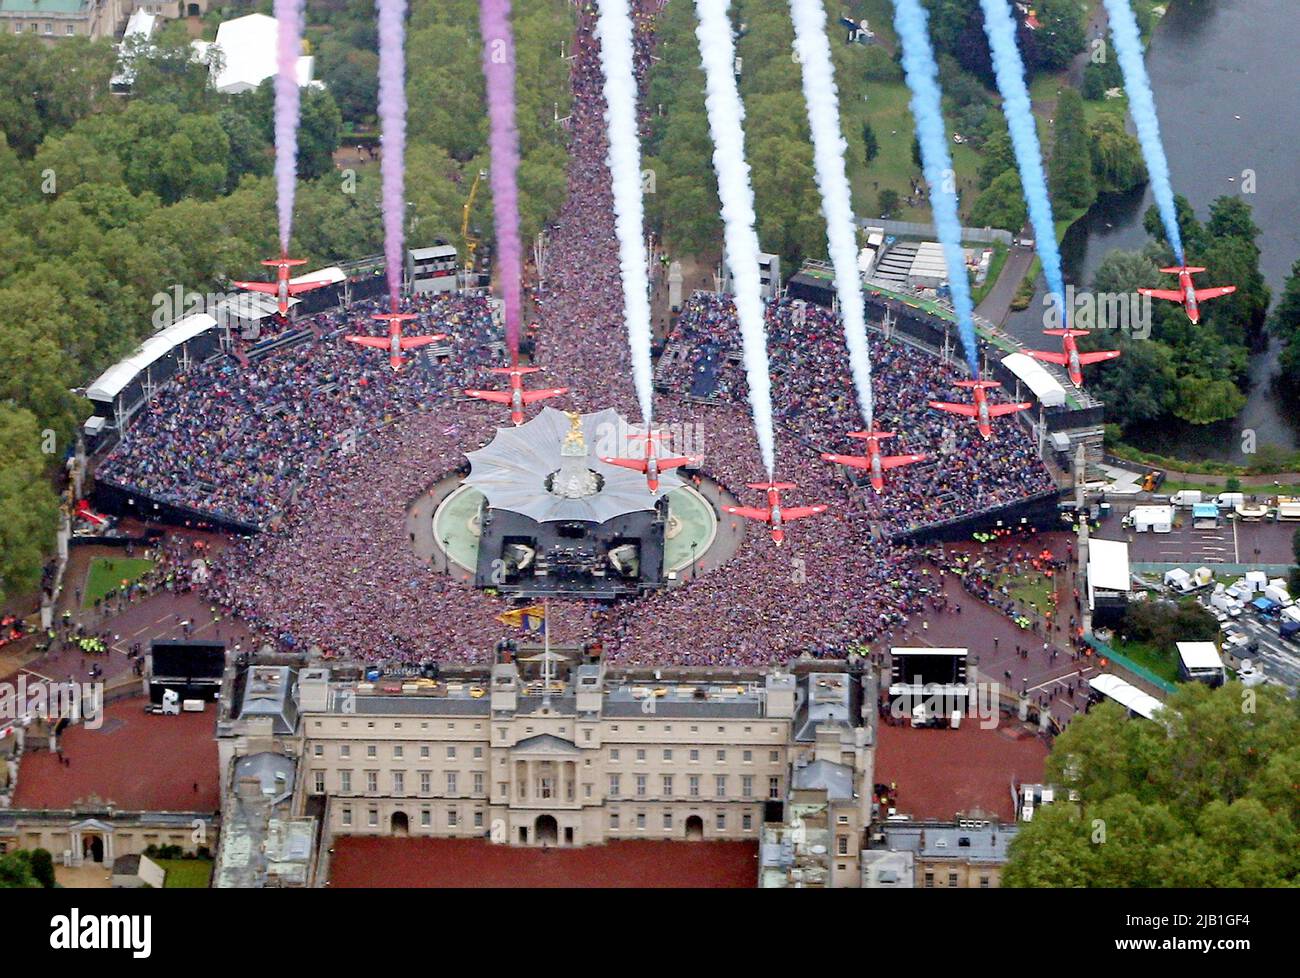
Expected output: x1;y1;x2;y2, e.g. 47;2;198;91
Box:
696;0;776;479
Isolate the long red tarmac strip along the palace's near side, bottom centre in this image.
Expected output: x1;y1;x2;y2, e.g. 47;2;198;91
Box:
330;836;758;888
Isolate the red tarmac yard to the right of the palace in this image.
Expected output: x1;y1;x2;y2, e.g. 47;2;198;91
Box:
876;717;1048;822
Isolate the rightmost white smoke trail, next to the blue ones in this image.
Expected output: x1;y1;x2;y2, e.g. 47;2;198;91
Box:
790;0;875;430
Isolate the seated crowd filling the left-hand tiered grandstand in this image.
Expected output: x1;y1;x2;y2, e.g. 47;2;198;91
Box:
96;293;501;527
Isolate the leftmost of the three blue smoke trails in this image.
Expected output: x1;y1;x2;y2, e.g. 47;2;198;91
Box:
894;0;979;377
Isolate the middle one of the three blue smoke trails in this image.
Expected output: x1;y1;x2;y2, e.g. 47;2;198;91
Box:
980;0;1069;326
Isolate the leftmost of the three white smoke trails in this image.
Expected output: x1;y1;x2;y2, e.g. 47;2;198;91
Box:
595;0;654;425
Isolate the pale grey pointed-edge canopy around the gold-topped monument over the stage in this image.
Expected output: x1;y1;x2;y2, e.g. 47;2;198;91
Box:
465;407;681;523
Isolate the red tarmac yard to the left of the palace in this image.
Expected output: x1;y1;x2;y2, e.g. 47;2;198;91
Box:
13;698;221;812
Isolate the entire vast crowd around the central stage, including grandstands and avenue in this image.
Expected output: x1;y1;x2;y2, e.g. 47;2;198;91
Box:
83;0;1066;666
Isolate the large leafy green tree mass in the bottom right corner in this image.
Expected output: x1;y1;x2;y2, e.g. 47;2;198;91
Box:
1002;683;1300;887
